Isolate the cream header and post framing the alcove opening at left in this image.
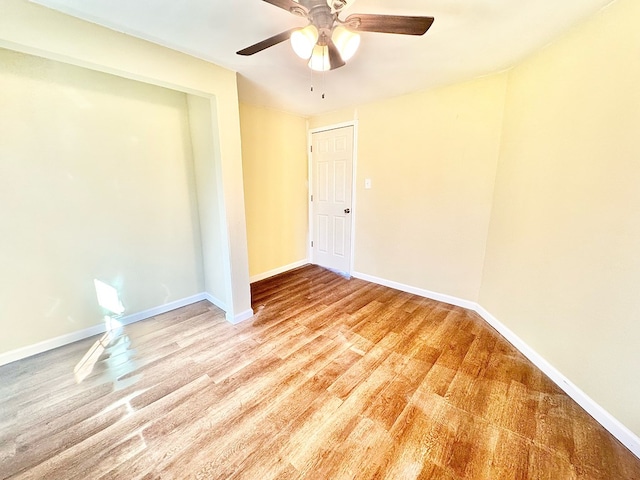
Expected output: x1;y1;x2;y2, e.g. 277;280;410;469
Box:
0;0;251;354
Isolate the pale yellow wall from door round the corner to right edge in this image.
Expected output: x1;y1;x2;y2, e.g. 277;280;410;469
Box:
310;0;640;434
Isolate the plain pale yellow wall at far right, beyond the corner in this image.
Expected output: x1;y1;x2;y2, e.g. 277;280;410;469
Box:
480;0;640;434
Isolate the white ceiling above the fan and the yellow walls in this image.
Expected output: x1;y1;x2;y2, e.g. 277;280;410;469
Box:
35;0;612;115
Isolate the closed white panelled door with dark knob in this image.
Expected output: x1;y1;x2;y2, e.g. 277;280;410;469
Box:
311;126;353;273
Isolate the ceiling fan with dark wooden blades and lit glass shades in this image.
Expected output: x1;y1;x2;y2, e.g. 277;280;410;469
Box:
236;0;434;71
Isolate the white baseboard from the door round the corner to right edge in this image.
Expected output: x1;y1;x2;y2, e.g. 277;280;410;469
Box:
353;272;640;458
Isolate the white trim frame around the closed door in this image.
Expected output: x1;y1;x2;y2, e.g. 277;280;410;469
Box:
307;120;358;276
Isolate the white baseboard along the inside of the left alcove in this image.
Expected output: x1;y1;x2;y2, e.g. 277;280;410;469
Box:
0;293;216;366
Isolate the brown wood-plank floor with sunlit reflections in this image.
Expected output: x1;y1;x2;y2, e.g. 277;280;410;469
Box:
0;266;640;480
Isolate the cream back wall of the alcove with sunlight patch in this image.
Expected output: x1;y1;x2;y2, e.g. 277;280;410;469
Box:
0;49;204;352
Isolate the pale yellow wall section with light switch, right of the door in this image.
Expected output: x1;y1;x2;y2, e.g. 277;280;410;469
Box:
311;75;506;301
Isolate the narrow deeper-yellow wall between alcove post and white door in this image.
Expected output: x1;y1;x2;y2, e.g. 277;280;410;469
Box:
240;104;308;276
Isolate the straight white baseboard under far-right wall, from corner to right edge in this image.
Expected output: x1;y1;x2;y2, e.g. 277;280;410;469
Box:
474;305;640;458
